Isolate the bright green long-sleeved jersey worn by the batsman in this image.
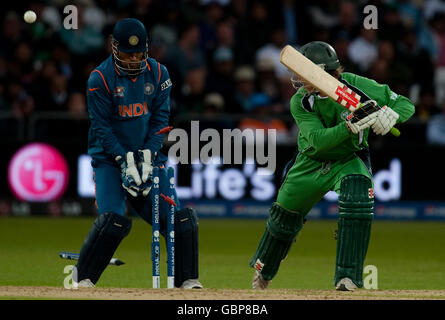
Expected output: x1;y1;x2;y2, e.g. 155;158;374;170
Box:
290;72;414;160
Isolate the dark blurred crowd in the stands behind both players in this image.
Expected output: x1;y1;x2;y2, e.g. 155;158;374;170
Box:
0;0;445;145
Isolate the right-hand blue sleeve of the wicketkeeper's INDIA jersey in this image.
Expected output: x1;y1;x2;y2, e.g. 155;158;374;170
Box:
144;65;172;152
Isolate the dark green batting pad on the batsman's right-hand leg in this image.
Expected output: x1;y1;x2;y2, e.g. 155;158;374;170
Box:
334;175;374;288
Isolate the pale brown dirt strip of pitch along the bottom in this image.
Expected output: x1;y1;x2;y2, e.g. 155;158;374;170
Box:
0;286;445;300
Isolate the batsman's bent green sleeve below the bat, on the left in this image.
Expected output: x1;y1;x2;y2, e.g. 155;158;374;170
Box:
290;94;350;152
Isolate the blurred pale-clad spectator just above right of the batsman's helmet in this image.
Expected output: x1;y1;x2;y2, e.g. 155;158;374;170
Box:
348;27;378;72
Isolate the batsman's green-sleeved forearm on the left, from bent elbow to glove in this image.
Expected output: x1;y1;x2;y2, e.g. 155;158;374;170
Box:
306;122;351;152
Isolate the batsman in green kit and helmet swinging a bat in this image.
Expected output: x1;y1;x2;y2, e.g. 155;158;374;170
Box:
250;41;414;291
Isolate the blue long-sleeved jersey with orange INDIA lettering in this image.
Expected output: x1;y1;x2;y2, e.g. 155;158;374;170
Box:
87;55;172;161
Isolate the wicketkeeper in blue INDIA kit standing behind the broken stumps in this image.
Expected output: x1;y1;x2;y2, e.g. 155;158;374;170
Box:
74;19;202;288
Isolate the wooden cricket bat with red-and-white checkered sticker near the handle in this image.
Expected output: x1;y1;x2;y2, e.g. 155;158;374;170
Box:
280;45;400;137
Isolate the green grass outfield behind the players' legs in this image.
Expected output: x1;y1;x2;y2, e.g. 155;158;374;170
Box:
0;217;445;290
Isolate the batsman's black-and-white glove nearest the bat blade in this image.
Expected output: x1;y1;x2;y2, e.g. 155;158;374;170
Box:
346;100;380;134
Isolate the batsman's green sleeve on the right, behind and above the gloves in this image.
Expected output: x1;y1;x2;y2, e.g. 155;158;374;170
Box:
343;73;415;123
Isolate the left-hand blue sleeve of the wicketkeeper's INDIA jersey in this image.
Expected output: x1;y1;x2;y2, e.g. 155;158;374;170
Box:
87;70;125;159
